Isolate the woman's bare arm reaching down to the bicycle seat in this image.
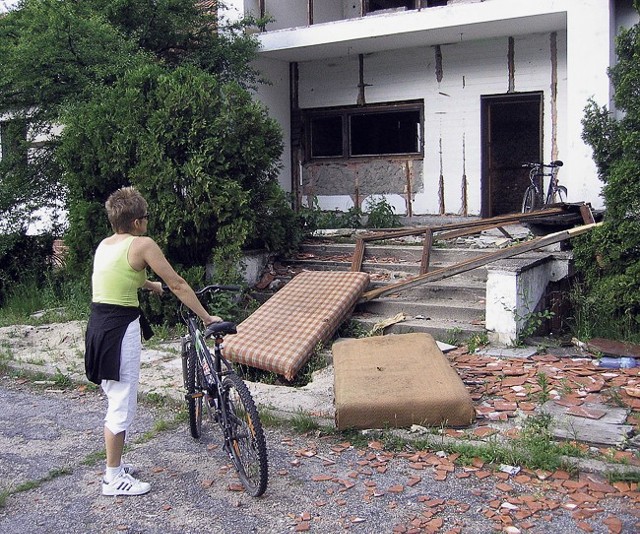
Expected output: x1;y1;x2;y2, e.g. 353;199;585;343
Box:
129;237;222;324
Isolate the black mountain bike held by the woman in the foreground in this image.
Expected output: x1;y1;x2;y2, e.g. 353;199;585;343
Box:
178;285;269;497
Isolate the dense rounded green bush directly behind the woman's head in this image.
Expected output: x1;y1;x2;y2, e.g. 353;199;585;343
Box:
58;65;294;281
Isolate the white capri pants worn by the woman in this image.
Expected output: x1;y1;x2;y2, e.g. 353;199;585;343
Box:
101;319;142;435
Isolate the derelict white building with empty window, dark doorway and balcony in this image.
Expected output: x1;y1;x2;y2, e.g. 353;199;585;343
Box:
225;0;638;217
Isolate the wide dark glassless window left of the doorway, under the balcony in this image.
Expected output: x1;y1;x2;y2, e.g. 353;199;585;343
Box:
307;102;423;159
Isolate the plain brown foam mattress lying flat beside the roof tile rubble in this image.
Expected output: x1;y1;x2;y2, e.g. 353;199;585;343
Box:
333;333;475;430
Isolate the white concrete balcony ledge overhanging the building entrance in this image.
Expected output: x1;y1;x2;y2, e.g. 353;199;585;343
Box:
249;0;567;61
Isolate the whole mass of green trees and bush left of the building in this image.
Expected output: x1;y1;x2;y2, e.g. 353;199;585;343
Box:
0;0;297;284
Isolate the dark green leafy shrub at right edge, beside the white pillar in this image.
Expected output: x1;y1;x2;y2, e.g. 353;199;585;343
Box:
576;0;640;340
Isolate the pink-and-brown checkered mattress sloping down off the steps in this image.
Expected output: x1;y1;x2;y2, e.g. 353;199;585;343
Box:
225;271;369;380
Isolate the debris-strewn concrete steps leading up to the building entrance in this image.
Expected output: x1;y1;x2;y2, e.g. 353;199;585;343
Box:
274;239;488;343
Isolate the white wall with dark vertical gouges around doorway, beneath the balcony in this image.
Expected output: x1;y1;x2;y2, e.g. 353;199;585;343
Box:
299;32;571;215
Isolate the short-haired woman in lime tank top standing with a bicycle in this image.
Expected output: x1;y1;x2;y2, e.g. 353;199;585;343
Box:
85;187;222;495
